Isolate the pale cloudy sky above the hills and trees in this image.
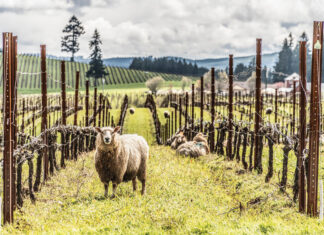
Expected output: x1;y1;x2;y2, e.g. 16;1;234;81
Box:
0;0;324;59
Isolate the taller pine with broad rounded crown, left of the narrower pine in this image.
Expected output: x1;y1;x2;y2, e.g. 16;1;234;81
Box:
61;15;85;61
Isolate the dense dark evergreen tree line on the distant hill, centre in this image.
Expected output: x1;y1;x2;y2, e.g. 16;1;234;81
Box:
129;56;208;76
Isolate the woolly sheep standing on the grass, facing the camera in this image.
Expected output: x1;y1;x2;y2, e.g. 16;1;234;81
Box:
95;126;149;198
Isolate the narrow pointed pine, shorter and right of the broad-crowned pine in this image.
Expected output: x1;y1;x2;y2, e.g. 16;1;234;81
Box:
86;29;108;87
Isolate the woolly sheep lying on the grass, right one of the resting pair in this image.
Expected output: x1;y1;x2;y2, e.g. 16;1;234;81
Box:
176;133;209;158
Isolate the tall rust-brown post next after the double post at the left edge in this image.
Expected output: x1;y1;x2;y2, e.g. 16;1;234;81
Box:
40;45;48;181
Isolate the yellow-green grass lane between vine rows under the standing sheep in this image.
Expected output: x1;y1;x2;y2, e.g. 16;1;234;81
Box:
3;108;324;234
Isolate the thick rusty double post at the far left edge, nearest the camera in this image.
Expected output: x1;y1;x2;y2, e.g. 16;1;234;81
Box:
0;33;17;224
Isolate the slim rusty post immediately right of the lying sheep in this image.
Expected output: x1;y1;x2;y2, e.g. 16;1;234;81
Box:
209;68;215;153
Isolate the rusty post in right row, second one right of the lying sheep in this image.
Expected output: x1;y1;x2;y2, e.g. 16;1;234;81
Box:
226;55;234;159
